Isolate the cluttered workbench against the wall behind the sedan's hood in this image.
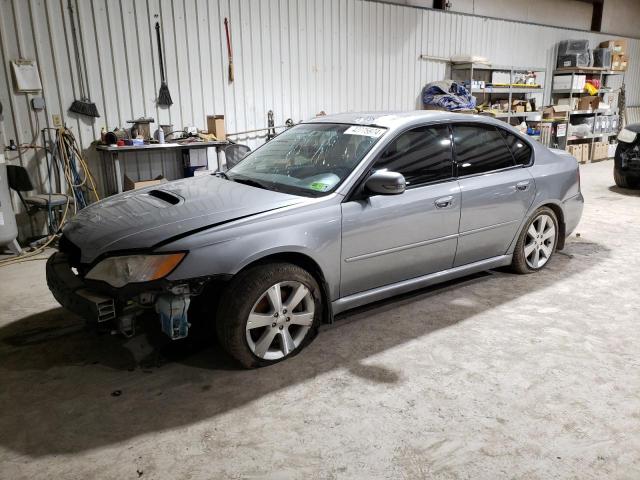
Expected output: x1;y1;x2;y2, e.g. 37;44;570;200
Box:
96;141;229;193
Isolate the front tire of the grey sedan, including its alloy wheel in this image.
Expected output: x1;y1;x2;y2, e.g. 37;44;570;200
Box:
216;263;322;368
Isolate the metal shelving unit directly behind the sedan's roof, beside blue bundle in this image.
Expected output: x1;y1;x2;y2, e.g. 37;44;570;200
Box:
451;63;547;123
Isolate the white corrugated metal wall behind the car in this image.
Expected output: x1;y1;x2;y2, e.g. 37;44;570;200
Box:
0;0;640;238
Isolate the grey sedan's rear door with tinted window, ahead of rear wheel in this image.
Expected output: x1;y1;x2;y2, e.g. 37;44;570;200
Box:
453;123;535;266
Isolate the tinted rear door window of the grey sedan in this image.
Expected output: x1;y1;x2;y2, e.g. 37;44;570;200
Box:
453;125;514;176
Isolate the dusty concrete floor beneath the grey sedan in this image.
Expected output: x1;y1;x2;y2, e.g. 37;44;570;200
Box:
0;161;640;479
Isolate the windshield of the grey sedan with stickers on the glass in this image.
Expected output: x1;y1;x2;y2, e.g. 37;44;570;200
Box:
227;123;386;197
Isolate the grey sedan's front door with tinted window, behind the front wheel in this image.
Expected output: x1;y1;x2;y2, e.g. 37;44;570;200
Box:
340;125;460;297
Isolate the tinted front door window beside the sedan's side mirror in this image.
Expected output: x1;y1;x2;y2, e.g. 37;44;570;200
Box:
375;125;453;186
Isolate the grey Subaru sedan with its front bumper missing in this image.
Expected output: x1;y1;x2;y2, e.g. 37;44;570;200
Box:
47;111;583;367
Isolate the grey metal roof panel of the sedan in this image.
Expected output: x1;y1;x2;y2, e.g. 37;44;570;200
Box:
304;110;496;128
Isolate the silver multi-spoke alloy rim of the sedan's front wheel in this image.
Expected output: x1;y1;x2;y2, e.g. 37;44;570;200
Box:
246;281;315;360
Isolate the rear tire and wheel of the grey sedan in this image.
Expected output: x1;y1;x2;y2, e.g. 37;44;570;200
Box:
511;207;559;274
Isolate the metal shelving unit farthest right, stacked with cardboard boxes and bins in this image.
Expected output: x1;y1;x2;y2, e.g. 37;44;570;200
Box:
551;67;625;162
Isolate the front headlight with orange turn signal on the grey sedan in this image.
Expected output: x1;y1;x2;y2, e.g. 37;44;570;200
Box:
86;253;186;288
